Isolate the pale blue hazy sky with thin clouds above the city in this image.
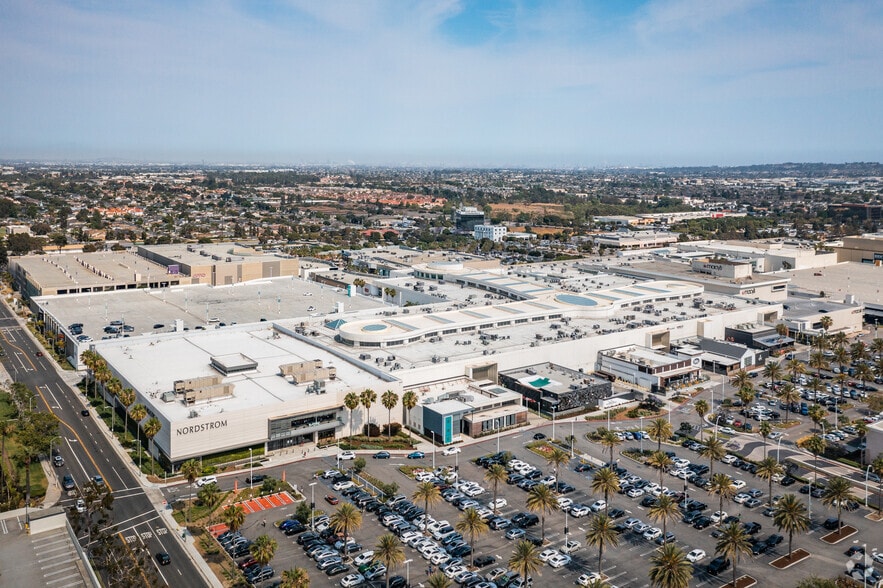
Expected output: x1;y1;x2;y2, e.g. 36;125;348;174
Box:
0;0;883;167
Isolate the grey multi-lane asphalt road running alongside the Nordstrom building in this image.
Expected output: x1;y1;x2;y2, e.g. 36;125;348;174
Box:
0;304;206;588
